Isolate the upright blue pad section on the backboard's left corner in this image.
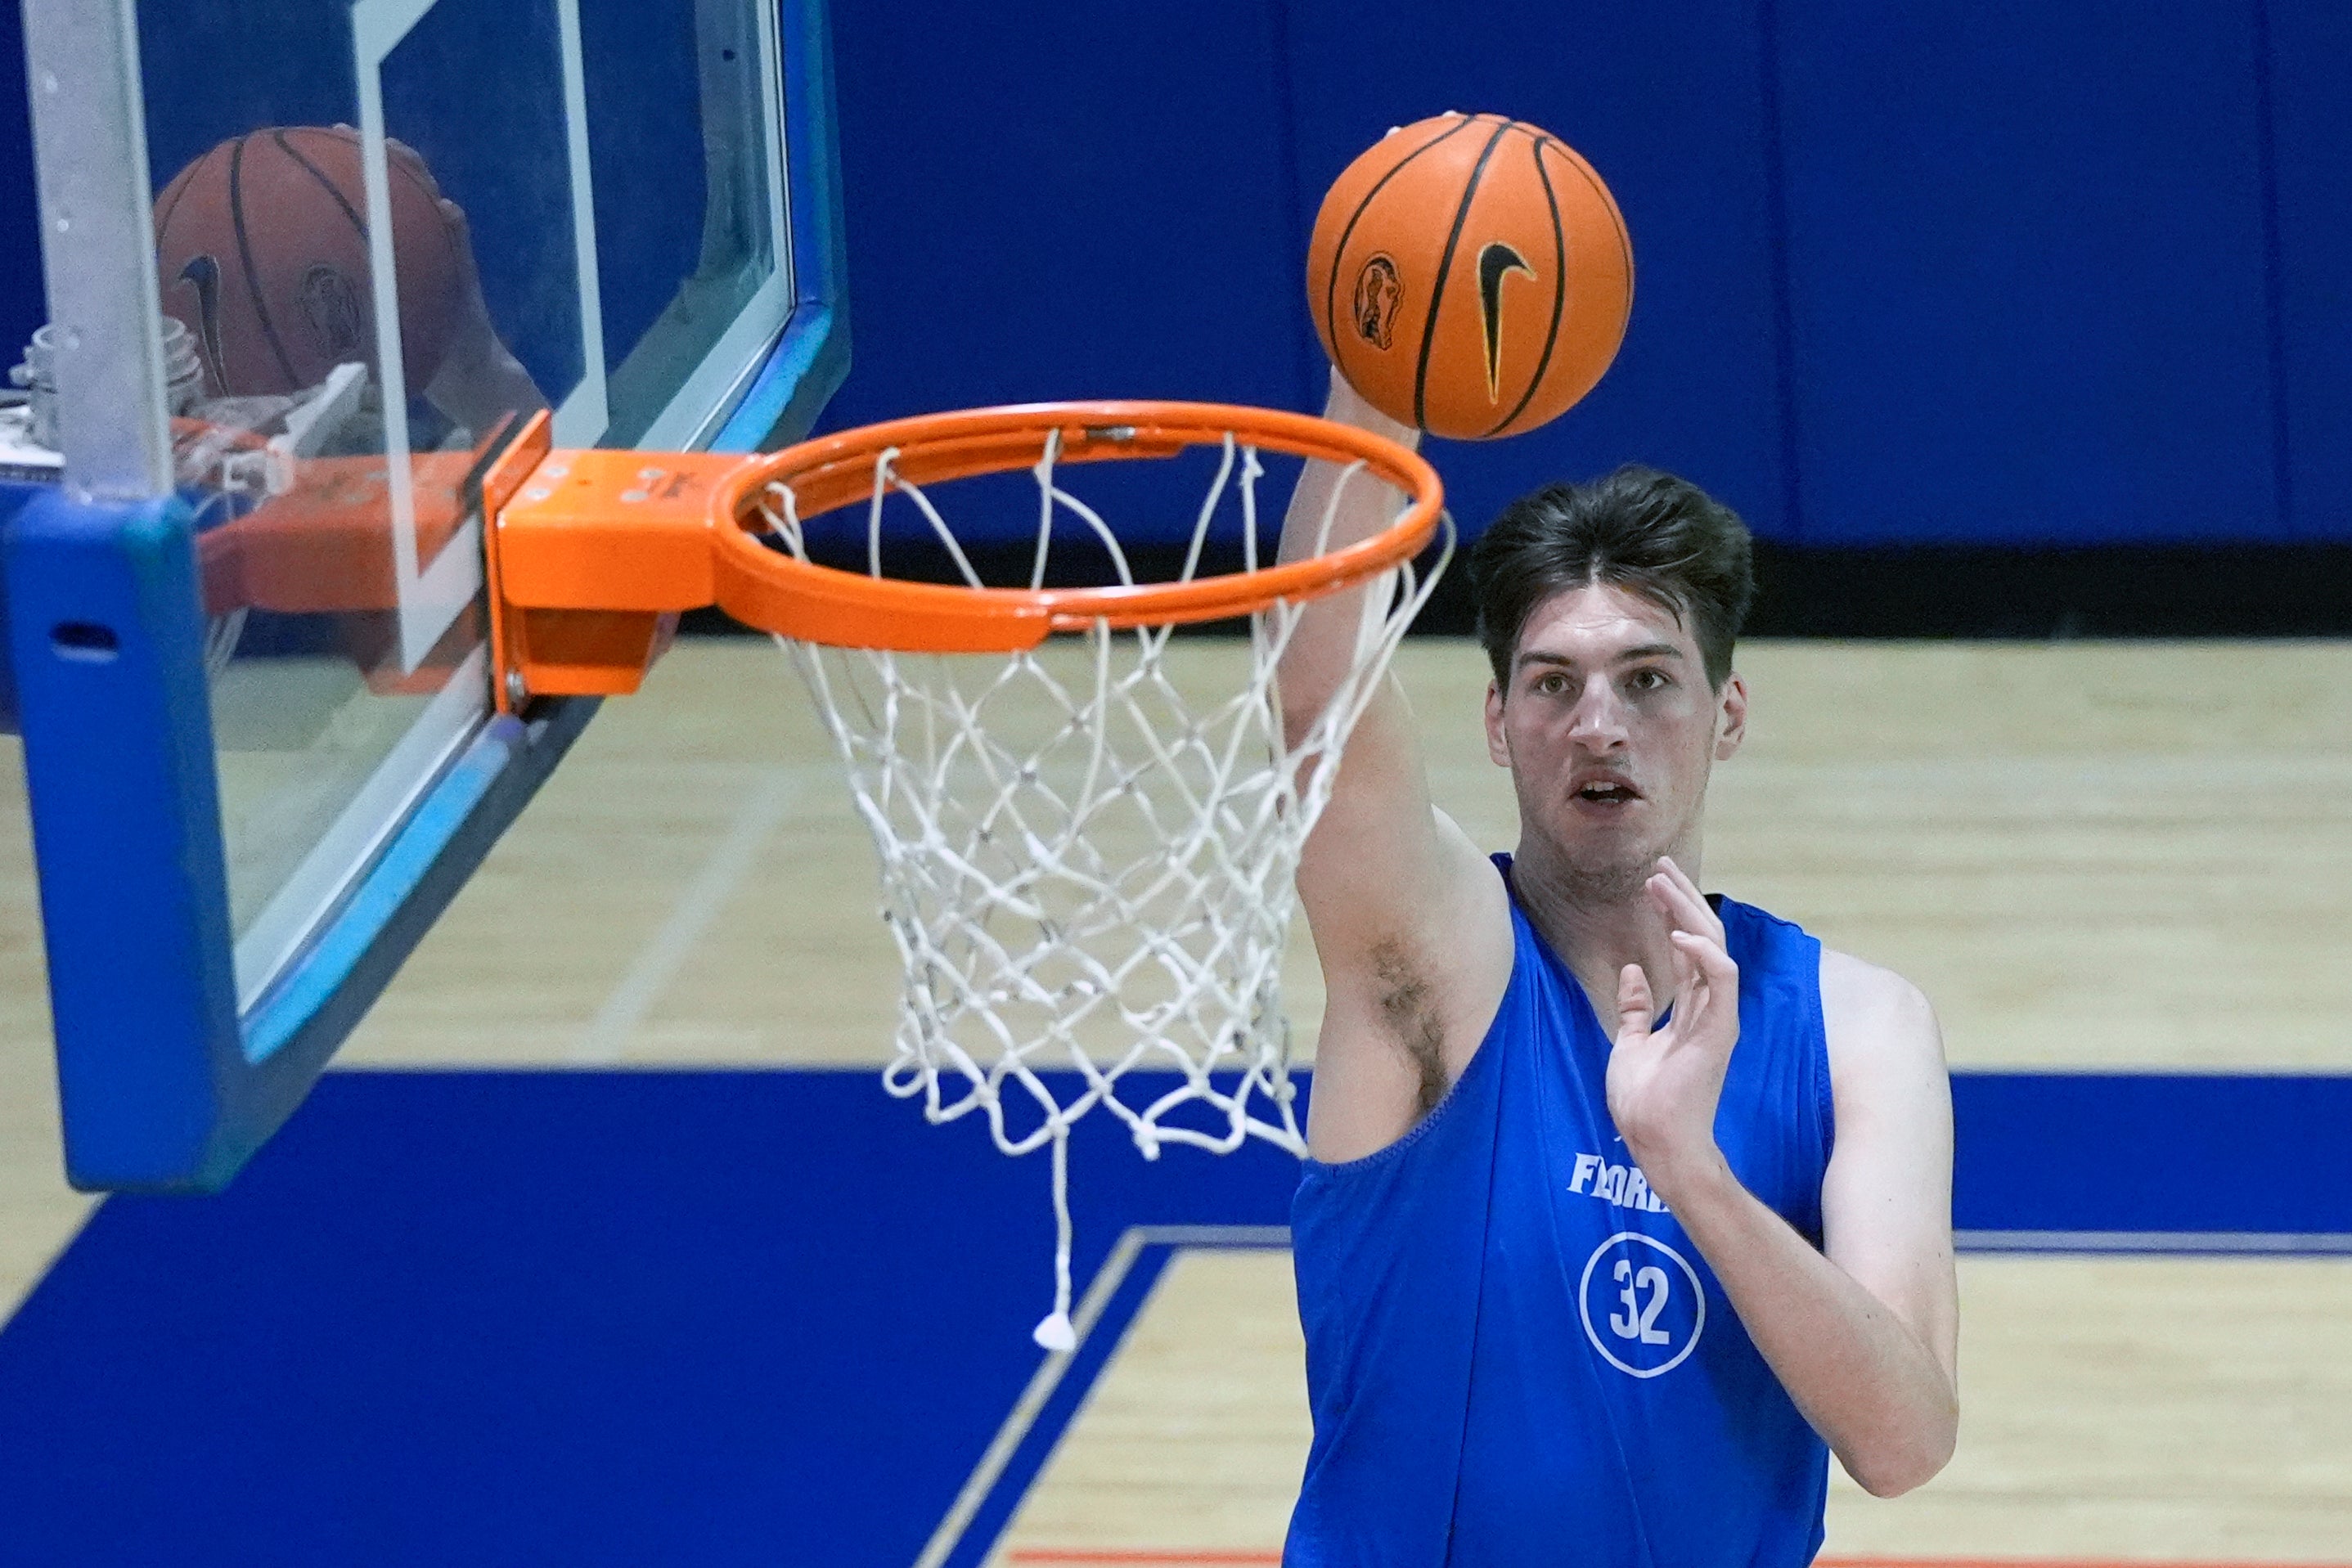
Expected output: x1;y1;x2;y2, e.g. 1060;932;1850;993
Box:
5;492;240;1185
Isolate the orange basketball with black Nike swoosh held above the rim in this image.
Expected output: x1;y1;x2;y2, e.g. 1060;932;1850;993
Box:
1308;115;1632;439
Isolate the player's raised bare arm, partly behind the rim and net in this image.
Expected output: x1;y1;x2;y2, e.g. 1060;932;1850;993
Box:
1279;376;1510;1161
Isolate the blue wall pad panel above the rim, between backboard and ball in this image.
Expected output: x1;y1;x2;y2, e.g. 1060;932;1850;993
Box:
823;0;1306;430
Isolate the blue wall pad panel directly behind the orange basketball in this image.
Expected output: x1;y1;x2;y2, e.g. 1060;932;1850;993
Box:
1289;0;1788;536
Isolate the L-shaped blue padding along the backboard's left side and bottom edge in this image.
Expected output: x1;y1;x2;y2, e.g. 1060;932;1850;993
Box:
5;492;595;1189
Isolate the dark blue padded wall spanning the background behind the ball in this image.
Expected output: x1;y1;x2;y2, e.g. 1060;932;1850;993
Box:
0;0;2352;546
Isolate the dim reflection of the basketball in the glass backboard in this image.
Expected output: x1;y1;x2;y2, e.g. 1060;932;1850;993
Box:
155;124;461;398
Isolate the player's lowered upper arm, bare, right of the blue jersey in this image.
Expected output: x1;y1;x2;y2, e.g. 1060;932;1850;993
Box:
1820;950;1959;1391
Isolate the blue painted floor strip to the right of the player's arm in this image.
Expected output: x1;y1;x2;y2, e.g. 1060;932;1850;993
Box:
1952;1072;2352;1237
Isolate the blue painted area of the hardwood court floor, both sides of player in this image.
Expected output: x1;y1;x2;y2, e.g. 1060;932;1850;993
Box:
0;1072;2352;1568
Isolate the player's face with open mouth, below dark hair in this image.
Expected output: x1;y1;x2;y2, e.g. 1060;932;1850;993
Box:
1486;583;1747;893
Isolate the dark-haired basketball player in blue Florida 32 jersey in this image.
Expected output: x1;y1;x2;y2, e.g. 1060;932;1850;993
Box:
1282;376;1959;1568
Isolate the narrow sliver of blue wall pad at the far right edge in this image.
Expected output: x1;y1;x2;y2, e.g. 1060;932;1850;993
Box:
2268;0;2352;538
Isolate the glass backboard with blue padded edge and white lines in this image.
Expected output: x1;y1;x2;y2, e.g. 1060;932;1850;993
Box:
10;0;847;1187
